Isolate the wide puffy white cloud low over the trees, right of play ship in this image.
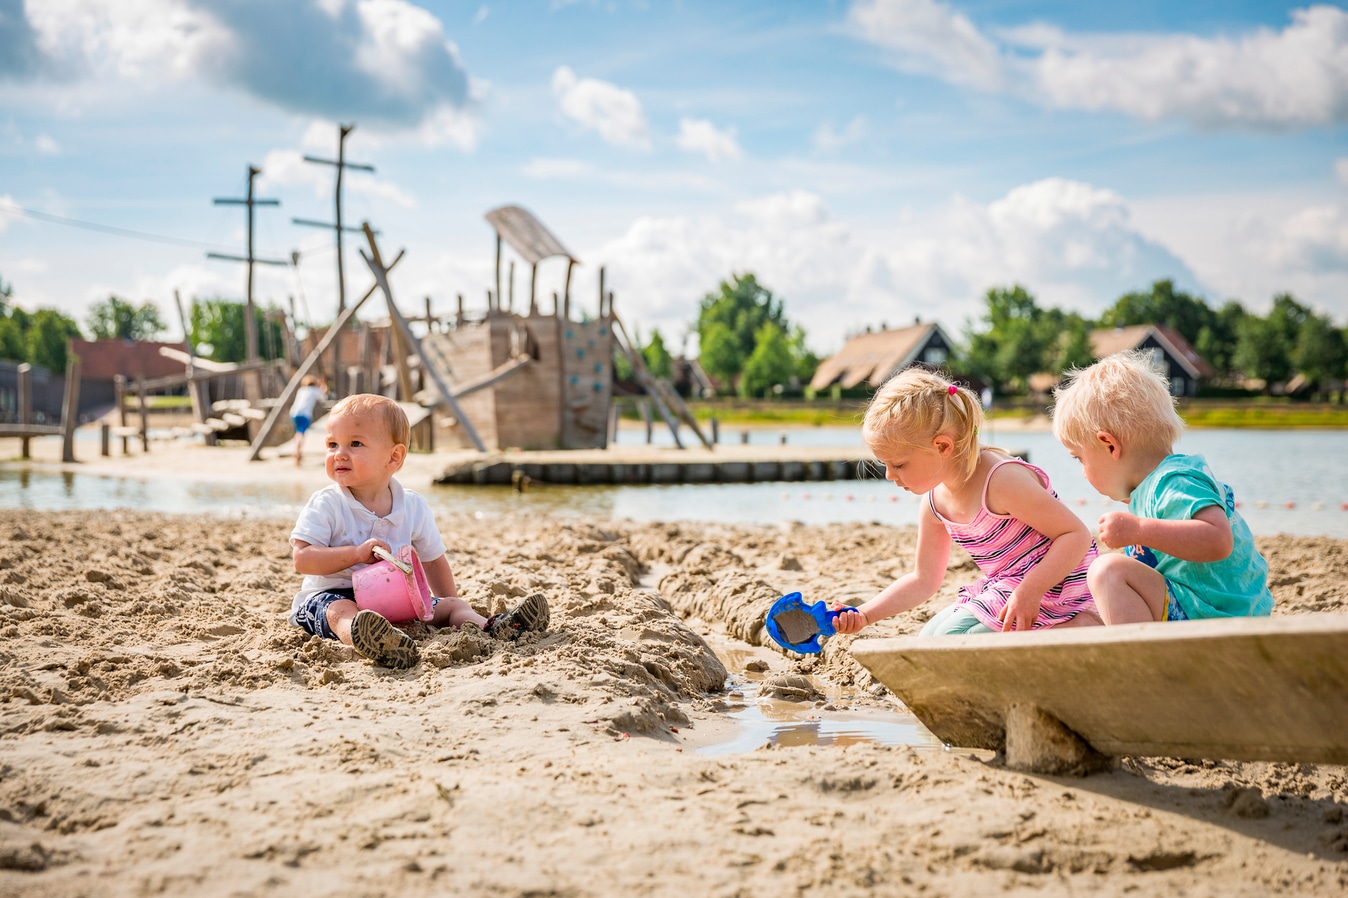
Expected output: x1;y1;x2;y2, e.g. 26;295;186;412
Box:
582;179;1196;352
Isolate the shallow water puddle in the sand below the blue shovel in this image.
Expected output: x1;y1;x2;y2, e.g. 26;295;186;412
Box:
697;635;941;755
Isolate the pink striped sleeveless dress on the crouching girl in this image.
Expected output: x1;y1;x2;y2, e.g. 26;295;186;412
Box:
927;458;1099;630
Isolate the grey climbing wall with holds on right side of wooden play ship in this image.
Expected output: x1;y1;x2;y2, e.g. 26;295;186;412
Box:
561;318;613;449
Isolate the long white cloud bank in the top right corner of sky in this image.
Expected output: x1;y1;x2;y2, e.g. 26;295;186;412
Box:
848;0;1348;129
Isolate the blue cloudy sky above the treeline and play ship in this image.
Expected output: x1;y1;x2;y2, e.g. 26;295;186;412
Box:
0;0;1348;353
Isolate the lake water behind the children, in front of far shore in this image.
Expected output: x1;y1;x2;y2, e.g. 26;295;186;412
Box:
0;425;1348;538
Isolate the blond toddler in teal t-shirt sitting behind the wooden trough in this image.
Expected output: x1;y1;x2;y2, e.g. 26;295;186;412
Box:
1053;351;1273;624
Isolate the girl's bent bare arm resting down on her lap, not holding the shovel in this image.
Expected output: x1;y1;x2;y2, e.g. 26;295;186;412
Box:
988;465;1091;632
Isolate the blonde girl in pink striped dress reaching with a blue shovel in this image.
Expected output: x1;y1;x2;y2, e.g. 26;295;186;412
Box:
834;368;1100;636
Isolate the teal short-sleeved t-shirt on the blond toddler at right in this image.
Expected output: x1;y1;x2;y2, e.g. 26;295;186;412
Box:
1128;454;1273;619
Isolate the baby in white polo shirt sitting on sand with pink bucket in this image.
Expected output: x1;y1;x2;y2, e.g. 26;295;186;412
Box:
290;394;547;669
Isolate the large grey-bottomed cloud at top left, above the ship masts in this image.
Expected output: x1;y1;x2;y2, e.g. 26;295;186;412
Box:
23;0;472;131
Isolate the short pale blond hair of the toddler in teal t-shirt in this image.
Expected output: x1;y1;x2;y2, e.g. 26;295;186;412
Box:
1053;349;1184;452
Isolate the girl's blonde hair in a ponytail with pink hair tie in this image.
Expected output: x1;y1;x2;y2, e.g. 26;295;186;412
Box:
861;368;983;476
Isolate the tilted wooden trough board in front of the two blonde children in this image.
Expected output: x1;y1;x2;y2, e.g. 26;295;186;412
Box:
851;613;1348;765
